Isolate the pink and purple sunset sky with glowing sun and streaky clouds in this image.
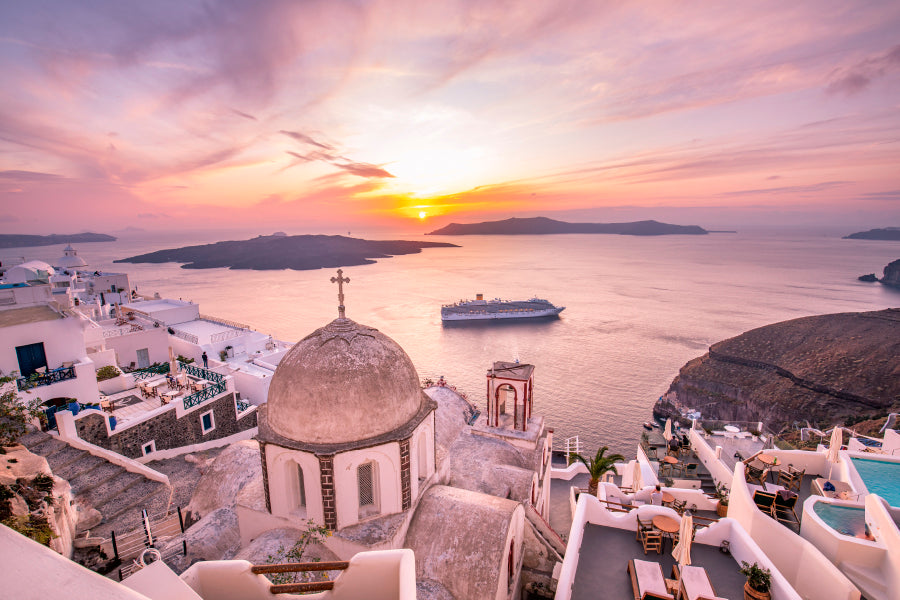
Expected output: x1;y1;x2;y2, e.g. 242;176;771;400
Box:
0;0;900;233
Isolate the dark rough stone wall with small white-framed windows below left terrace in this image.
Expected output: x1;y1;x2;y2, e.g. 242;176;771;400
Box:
76;393;256;458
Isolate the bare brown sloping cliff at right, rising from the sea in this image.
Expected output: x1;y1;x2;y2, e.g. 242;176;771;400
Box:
655;310;900;430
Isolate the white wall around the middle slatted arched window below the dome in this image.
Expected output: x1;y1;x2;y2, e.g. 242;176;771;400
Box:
334;442;402;529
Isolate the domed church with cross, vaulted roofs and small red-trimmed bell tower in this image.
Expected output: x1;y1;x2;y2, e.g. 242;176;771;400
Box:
236;270;564;600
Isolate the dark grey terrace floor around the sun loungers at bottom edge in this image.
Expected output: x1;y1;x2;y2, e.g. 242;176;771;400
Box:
572;524;747;600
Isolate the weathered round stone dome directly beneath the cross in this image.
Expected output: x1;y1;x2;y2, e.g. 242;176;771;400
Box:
266;319;424;444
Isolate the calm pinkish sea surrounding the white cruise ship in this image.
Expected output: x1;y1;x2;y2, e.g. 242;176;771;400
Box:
0;232;900;456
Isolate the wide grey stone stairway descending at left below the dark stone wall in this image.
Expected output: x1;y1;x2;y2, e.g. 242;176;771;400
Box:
19;431;172;538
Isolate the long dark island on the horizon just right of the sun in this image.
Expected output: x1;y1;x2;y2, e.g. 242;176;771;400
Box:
426;217;709;235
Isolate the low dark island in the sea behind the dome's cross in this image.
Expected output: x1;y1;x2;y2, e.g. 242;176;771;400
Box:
115;232;459;271
